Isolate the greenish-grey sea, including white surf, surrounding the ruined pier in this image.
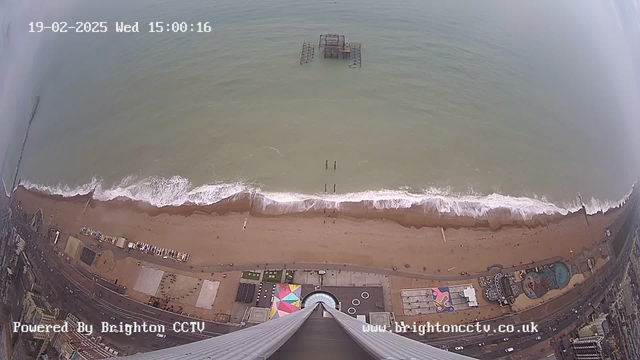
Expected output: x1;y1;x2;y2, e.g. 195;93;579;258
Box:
0;0;640;218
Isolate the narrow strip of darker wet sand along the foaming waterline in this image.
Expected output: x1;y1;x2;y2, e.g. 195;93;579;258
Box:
12;185;635;231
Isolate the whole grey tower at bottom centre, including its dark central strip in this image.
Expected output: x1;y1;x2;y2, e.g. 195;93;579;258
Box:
117;302;470;360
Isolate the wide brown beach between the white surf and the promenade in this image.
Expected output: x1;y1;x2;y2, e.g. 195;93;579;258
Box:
12;188;628;275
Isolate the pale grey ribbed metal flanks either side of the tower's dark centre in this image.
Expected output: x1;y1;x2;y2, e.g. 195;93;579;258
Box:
114;303;471;360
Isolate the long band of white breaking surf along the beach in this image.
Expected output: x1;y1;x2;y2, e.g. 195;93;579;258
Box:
21;176;635;220
